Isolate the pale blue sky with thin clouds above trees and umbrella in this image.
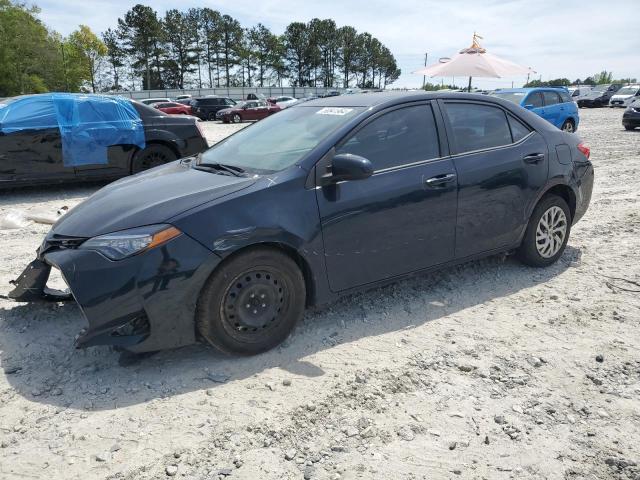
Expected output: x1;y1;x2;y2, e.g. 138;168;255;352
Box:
33;0;640;88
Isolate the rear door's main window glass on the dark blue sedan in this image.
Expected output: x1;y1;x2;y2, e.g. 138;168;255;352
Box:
445;102;511;153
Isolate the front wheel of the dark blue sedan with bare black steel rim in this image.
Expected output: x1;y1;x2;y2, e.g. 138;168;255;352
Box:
196;247;306;355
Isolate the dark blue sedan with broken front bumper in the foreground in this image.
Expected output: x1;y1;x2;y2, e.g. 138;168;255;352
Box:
11;93;593;354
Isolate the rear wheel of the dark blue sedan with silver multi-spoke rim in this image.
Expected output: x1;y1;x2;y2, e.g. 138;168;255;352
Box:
517;195;571;267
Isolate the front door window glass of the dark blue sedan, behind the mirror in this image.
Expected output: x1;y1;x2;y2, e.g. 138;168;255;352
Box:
337;105;440;170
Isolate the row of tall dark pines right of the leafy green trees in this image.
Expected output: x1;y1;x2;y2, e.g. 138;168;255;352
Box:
109;4;400;89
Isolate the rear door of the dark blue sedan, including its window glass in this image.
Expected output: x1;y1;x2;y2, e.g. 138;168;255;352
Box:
440;100;549;259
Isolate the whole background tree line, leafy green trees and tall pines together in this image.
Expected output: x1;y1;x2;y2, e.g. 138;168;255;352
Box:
0;0;400;97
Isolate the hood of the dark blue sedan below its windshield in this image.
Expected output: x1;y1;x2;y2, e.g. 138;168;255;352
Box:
52;160;255;238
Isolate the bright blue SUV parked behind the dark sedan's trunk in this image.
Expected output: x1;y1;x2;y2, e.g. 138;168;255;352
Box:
492;87;580;133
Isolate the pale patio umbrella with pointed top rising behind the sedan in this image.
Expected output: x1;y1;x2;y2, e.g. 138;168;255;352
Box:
413;33;535;91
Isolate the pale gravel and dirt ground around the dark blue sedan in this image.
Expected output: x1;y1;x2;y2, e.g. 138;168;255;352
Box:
0;109;640;480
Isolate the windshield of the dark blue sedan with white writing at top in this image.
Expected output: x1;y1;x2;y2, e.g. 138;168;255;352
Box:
200;107;363;174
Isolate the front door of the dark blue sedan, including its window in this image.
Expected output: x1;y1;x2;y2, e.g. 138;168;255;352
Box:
316;102;457;291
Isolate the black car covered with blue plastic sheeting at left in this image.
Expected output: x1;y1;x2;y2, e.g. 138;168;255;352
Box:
0;93;207;188
